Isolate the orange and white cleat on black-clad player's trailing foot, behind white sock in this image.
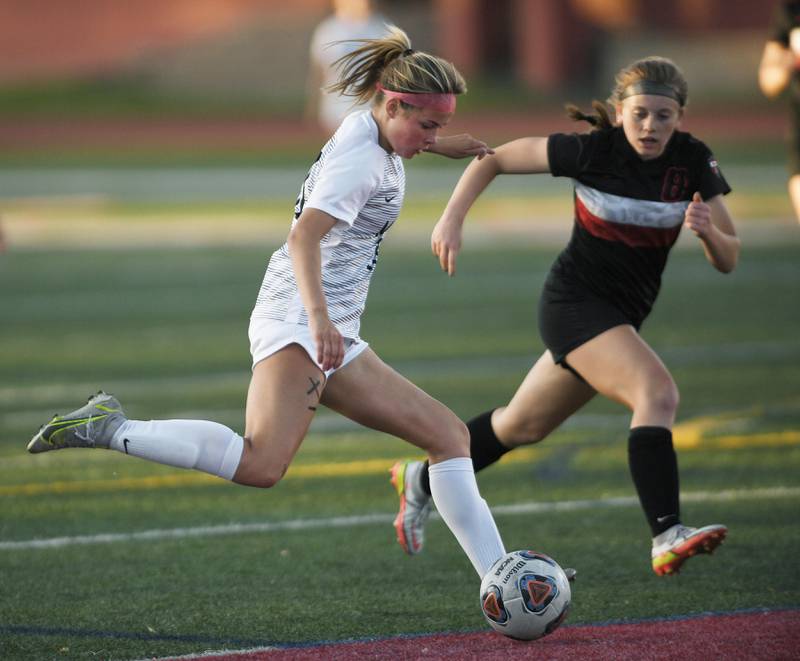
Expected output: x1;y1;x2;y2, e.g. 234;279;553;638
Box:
391;461;432;555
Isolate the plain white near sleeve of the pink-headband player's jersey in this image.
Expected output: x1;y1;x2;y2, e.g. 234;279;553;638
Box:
305;140;384;225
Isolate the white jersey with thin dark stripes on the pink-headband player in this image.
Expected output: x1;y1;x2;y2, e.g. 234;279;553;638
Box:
252;110;405;338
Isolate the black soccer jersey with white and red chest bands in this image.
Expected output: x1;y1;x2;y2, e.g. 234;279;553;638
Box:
547;127;730;327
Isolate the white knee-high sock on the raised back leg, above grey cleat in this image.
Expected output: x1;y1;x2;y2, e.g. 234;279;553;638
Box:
110;420;244;480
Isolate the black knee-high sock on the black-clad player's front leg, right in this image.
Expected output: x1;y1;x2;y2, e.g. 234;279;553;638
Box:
628;427;680;537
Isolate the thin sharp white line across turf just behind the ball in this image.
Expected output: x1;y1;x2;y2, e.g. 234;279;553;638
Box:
0;487;800;551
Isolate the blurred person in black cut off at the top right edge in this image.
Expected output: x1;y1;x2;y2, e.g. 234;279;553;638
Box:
758;0;800;220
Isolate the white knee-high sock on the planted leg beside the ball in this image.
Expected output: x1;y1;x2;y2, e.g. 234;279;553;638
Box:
428;457;506;578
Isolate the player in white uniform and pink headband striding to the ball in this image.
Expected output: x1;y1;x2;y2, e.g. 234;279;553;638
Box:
28;27;505;577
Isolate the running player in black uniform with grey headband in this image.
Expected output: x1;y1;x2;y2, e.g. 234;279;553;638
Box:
394;57;739;575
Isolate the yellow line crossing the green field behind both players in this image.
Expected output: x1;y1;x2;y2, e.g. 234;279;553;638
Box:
0;428;800;496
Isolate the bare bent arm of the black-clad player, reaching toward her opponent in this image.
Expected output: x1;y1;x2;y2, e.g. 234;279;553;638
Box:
431;138;550;275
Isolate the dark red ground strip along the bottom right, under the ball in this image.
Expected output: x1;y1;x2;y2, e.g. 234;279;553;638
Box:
182;610;800;661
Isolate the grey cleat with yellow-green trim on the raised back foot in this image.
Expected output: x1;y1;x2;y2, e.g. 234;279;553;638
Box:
28;390;127;454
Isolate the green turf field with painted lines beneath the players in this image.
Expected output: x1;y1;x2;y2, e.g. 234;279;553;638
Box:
0;214;800;659
